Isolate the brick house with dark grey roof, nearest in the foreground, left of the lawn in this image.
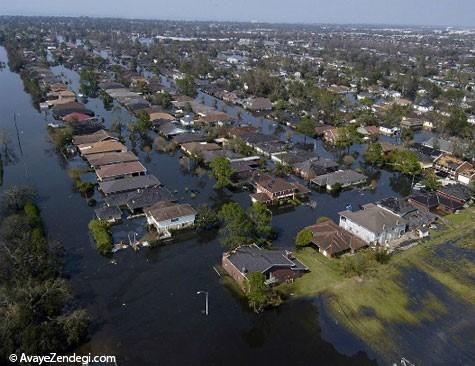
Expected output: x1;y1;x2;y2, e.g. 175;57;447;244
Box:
221;245;309;291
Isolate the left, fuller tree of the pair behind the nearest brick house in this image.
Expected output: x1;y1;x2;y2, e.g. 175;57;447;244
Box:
218;202;255;249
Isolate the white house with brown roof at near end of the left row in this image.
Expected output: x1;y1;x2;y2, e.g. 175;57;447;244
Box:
144;201;196;237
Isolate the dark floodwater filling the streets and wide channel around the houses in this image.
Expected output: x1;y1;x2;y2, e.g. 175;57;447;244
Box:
0;43;456;365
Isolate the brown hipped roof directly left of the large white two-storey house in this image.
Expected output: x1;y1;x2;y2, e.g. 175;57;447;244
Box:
307;220;367;256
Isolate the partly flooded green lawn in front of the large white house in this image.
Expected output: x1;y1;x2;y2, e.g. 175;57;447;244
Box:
289;207;475;353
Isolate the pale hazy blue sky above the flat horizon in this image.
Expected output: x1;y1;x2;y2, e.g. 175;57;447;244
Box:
0;0;475;26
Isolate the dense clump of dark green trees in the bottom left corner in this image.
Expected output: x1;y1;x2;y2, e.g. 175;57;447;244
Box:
0;189;89;359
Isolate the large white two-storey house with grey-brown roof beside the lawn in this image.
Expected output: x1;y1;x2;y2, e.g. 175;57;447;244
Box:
338;203;407;245
